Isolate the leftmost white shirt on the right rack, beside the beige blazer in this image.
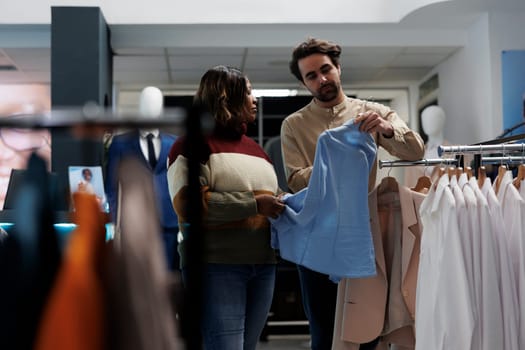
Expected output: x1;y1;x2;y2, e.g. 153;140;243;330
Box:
416;174;474;350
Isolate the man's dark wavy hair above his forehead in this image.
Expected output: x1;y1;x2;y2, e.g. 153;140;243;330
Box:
290;38;341;82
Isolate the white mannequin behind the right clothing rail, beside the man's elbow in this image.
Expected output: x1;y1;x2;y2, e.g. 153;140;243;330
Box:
405;105;449;188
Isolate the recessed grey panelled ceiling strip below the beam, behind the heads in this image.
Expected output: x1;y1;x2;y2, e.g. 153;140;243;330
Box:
0;38;458;89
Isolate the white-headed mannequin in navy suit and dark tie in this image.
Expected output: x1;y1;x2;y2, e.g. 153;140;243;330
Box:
106;86;179;271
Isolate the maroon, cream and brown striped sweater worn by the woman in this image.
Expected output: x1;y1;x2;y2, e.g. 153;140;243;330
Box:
167;134;278;266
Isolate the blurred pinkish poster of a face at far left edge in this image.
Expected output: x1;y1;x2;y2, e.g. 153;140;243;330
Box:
0;84;51;209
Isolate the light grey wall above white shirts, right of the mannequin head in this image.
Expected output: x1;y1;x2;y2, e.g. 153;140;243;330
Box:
423;12;525;144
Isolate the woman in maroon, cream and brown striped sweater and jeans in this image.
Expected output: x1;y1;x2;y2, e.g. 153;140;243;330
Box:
168;66;284;350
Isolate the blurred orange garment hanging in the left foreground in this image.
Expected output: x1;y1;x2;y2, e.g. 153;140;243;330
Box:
35;193;105;350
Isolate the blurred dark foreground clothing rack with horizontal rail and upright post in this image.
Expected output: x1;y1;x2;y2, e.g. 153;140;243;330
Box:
0;105;207;349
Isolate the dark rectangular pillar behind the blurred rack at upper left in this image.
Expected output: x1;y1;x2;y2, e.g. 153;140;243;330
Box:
51;7;113;206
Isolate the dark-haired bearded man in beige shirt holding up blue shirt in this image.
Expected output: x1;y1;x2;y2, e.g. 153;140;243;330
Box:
281;38;424;350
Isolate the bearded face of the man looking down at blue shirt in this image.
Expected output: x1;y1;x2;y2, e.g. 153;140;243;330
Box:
298;53;341;102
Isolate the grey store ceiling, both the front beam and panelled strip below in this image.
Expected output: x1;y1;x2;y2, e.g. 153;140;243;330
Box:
0;0;525;90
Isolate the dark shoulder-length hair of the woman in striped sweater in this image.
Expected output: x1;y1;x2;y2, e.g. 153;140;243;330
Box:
193;66;248;125
